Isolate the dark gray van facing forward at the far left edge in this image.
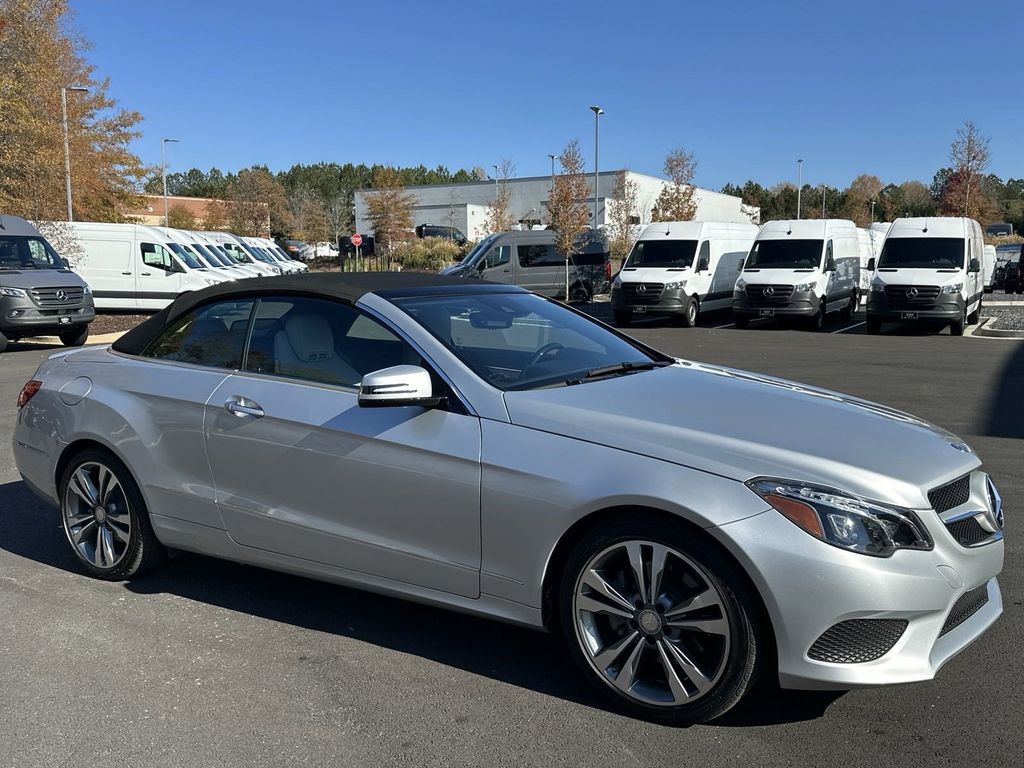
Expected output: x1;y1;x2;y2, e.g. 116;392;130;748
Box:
0;214;96;352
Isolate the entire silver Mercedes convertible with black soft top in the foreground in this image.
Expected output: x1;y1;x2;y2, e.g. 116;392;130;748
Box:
14;273;1004;722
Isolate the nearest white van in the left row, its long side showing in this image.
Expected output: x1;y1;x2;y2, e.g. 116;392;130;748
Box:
62;221;225;310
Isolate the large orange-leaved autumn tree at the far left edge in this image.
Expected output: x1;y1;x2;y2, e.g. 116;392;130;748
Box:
0;0;145;220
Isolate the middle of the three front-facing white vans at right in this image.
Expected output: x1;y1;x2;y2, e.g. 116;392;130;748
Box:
732;219;860;329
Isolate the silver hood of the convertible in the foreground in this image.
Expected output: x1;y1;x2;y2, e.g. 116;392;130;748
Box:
505;360;980;509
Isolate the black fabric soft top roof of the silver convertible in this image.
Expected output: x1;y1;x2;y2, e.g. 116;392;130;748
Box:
112;272;524;354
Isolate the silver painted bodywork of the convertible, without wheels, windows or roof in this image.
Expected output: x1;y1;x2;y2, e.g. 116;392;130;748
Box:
14;295;1004;688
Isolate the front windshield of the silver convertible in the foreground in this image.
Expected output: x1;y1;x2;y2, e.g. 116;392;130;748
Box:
395;293;672;390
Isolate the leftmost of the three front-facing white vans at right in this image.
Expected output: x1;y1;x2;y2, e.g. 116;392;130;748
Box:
611;221;758;328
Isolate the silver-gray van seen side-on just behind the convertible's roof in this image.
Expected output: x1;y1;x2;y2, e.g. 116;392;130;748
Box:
440;229;611;302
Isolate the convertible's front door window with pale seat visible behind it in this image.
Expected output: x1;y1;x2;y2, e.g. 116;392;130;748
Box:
245;296;423;387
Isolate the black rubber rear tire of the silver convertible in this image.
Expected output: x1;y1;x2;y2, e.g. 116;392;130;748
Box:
59;449;167;582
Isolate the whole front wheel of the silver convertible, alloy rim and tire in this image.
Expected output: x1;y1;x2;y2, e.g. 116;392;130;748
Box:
559;521;759;723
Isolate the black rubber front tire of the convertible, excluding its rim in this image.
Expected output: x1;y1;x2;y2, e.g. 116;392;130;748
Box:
557;519;769;724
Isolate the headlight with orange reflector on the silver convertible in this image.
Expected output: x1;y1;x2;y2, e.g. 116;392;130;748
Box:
746;477;933;557
